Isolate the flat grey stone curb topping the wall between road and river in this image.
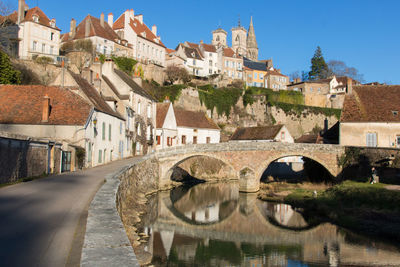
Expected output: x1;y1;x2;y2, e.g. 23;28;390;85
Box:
81;158;142;267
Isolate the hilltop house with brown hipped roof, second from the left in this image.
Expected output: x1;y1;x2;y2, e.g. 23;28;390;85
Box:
61;13;133;57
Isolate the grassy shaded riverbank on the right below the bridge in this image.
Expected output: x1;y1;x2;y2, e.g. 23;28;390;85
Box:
259;181;400;242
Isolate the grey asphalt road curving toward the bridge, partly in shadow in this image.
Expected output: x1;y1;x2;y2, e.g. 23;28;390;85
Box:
0;159;133;267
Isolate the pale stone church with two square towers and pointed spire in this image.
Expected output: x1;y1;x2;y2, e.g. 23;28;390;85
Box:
212;17;258;61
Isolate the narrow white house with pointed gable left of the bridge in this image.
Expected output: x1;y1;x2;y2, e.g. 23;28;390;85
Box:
156;102;178;149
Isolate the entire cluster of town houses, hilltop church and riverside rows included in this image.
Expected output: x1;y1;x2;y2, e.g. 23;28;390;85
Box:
0;0;400;182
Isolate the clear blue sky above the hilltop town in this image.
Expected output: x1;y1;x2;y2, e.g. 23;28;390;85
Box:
10;0;400;84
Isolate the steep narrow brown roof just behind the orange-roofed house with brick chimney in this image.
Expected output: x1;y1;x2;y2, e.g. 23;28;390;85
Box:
69;71;125;120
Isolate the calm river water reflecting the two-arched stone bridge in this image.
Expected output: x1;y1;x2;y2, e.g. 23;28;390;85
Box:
136;183;400;266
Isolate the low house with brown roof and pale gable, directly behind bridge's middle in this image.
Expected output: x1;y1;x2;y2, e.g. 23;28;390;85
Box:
230;124;294;143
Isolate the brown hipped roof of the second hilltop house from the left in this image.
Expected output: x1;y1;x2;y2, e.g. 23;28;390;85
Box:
61;15;120;42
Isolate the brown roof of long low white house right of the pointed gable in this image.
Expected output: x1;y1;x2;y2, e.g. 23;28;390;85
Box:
174;108;220;130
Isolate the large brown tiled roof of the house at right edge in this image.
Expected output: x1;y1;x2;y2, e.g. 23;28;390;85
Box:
340;85;400;122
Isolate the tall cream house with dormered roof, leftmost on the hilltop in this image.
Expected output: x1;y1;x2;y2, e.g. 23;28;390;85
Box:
0;0;61;61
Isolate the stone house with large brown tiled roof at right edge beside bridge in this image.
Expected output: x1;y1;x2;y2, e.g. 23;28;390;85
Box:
339;85;400;148
